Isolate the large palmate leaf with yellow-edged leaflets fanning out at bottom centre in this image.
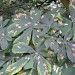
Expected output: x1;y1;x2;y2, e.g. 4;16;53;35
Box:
6;42;51;75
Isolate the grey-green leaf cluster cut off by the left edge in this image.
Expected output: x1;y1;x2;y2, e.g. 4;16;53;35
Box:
0;16;12;50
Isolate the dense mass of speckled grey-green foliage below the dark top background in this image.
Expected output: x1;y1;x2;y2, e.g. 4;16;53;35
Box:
0;0;75;75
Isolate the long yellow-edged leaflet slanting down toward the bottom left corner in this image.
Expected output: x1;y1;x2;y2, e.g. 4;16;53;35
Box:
6;57;30;75
